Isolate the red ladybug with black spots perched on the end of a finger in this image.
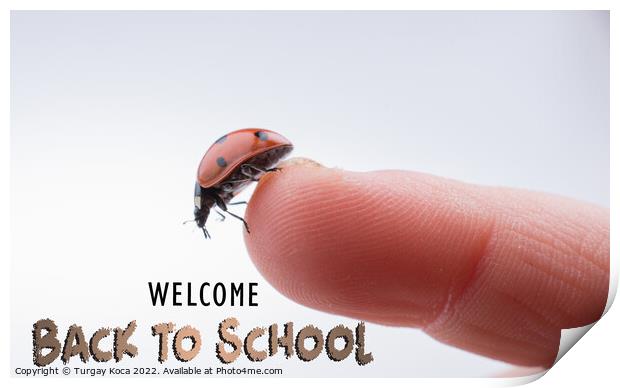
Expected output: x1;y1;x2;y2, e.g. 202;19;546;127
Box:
194;128;293;238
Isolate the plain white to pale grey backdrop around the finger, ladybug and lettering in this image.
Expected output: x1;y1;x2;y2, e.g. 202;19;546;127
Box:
11;12;609;376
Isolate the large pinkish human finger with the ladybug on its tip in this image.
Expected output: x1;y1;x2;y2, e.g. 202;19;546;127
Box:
245;159;609;368
